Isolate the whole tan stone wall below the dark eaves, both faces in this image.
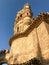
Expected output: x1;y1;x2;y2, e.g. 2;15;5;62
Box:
10;21;49;63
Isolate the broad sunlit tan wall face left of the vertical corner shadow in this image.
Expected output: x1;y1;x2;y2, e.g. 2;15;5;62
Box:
11;28;38;63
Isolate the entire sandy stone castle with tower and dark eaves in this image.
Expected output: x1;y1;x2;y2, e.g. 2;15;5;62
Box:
0;3;49;65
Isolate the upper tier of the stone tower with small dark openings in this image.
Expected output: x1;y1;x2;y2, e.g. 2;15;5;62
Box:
15;3;33;23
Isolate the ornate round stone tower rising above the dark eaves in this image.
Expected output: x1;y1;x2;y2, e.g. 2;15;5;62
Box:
14;3;32;35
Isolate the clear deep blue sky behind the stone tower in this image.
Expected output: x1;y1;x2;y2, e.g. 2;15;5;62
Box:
0;0;49;64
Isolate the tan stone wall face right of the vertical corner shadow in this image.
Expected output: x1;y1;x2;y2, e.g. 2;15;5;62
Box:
37;21;49;62
